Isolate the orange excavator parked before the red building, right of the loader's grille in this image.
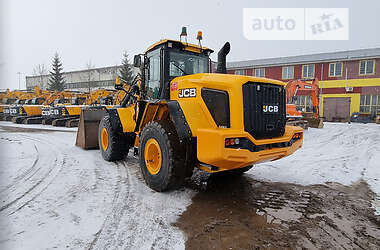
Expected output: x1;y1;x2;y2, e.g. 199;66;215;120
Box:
286;78;323;128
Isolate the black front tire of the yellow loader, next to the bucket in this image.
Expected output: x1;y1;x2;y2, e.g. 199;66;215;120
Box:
98;115;134;161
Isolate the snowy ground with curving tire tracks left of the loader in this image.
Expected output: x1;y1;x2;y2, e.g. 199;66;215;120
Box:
0;125;193;249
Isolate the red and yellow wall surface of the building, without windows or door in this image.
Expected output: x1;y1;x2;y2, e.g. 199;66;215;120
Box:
227;57;380;116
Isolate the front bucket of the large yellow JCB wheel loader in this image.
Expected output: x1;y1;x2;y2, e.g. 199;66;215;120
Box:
75;107;107;149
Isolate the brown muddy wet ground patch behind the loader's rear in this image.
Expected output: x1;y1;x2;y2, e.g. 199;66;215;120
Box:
175;172;380;249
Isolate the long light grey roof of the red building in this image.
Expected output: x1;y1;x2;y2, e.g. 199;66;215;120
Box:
227;48;380;69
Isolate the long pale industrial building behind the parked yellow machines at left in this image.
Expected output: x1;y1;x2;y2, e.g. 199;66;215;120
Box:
26;66;139;92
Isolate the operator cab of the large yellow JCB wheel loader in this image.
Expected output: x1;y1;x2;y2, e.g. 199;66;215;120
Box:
134;40;213;100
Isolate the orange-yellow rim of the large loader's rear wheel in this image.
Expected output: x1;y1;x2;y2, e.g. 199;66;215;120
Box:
144;138;162;175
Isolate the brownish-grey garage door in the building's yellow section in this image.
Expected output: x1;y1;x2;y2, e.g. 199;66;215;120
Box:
323;97;351;122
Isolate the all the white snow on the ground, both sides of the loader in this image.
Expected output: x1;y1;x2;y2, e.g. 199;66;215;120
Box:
0;122;380;249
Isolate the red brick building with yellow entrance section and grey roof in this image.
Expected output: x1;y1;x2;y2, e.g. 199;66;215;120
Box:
227;48;380;120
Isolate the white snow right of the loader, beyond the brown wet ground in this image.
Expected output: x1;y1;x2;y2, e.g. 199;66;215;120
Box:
248;123;380;212
